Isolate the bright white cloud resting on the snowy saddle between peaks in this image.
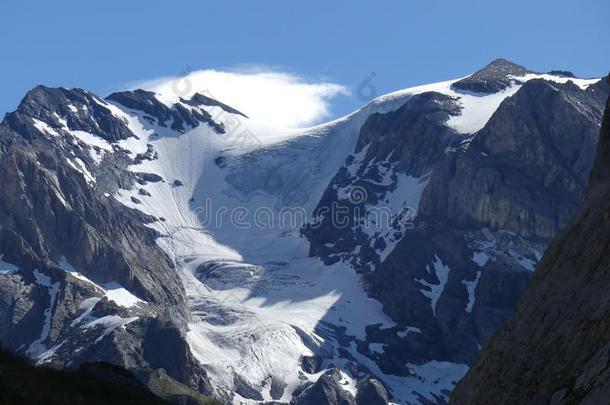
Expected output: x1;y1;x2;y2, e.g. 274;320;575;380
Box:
134;69;349;128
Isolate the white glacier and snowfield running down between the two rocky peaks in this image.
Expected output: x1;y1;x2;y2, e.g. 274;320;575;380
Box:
92;63;594;403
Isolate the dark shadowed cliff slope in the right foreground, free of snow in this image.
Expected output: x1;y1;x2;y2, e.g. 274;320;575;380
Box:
451;75;610;405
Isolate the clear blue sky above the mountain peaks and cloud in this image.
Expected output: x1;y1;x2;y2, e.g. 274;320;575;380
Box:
0;0;610;123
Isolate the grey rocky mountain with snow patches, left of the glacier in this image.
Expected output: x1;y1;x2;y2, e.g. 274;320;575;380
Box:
0;87;211;392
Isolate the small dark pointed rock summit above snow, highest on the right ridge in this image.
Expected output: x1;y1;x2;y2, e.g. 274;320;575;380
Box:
452;59;531;93
